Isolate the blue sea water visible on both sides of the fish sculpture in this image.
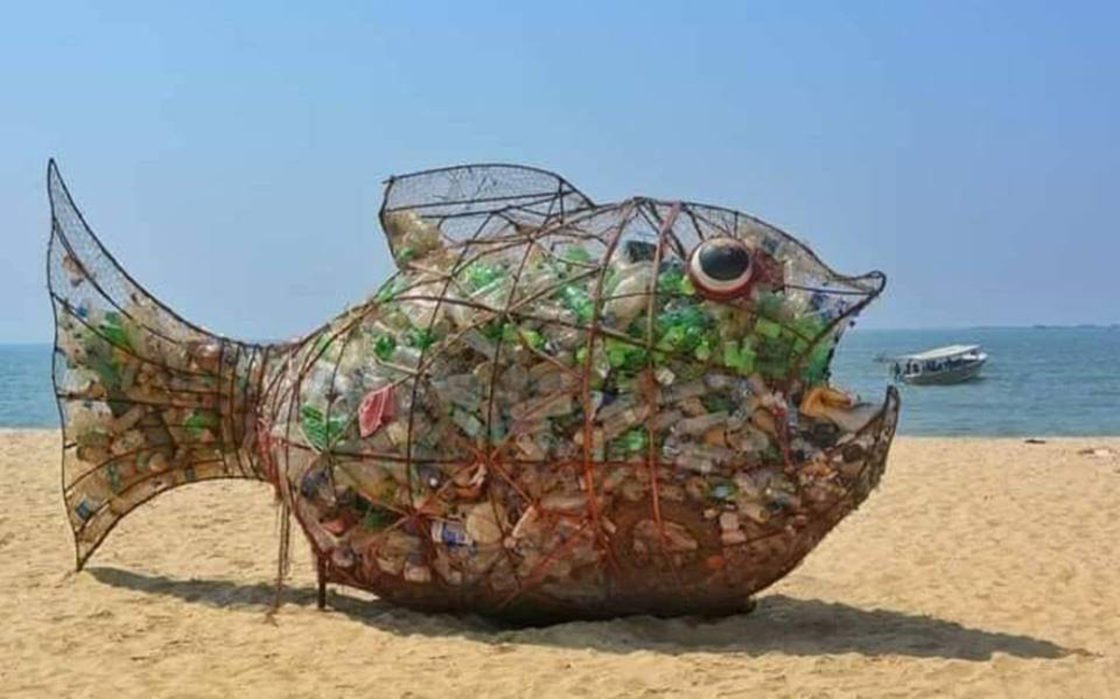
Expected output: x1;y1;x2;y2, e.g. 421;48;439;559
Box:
0;327;1120;437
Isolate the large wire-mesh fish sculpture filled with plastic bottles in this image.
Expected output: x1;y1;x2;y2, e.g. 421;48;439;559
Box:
48;162;899;622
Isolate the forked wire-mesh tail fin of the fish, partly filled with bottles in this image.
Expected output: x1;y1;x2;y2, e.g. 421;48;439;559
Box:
47;160;271;569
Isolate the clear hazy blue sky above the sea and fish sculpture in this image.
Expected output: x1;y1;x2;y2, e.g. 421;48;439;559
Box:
0;1;1120;342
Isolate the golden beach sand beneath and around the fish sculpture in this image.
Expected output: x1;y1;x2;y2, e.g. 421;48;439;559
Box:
0;431;1120;699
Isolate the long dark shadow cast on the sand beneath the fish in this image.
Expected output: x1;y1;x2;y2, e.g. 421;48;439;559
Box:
87;567;1085;661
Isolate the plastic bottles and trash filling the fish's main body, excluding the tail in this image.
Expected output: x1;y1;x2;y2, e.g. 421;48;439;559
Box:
264;166;893;616
